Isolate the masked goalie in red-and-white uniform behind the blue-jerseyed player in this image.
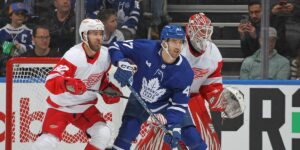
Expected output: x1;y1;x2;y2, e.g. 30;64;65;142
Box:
182;13;244;150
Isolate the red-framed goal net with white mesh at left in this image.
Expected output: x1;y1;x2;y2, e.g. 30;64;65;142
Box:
5;58;59;150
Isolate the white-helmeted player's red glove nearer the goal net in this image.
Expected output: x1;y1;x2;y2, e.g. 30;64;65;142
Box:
65;78;86;95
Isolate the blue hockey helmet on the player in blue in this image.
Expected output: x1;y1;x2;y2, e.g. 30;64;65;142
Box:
160;25;185;40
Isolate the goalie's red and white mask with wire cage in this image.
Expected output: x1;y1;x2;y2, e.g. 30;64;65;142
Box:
186;13;213;53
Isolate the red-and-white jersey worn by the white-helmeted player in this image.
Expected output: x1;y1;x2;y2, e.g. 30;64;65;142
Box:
46;43;111;113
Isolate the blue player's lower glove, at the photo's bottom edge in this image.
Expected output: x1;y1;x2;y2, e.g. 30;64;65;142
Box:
164;128;181;149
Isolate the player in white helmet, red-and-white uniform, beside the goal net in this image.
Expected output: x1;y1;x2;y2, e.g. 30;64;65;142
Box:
32;19;120;150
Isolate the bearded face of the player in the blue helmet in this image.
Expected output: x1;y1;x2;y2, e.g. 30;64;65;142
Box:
167;38;183;58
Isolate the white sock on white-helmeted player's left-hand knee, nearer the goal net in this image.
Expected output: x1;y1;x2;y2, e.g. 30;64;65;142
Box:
31;134;59;150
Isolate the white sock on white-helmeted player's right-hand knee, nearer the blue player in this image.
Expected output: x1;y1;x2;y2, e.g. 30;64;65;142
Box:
87;122;112;149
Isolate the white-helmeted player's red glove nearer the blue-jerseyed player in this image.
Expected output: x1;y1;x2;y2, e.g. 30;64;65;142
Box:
101;83;123;104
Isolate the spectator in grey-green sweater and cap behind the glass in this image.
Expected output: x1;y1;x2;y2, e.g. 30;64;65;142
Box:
240;27;290;80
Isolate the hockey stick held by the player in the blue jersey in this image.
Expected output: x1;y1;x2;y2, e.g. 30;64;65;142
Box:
127;83;183;150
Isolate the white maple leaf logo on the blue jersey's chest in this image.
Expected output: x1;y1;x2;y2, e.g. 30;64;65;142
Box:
140;78;166;103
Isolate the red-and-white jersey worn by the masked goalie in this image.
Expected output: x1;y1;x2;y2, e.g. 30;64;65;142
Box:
181;41;223;111
